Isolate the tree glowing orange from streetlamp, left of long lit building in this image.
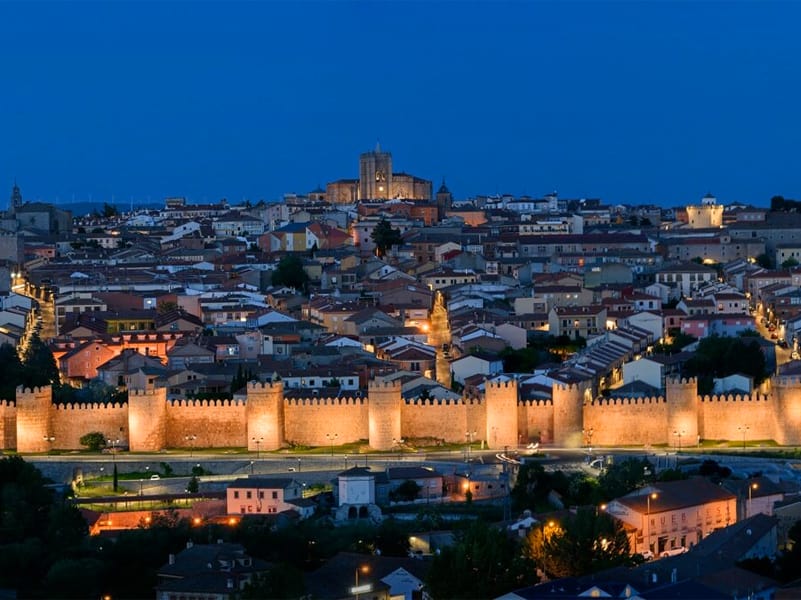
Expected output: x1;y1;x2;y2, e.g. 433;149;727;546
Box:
527;507;631;578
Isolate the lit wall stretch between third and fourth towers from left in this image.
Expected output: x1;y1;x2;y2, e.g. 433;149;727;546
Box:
284;398;369;446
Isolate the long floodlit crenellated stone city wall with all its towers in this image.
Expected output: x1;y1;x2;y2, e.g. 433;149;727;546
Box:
0;378;801;453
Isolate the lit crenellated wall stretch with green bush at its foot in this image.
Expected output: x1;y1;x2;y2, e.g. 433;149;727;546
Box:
50;403;128;450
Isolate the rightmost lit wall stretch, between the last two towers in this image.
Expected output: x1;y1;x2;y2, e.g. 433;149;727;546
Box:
688;394;776;444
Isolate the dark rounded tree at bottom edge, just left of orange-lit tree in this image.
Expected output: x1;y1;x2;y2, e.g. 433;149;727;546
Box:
426;521;537;598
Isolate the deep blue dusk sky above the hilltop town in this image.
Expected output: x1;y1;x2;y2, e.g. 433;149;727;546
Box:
0;0;801;206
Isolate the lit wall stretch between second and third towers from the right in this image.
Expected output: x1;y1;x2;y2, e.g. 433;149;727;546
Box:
584;396;668;446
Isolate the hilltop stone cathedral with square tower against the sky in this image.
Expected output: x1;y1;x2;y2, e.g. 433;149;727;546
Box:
325;144;432;204
